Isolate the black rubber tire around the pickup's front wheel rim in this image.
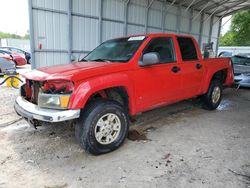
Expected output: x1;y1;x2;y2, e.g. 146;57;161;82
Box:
75;100;129;155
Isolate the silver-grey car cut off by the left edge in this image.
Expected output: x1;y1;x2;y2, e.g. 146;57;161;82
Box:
0;53;16;75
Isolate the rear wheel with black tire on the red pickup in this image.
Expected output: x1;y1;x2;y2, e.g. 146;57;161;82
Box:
201;80;223;110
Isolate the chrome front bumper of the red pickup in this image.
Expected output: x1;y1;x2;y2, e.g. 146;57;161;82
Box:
14;96;80;122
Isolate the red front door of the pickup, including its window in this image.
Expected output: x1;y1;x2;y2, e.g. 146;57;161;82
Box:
134;37;181;112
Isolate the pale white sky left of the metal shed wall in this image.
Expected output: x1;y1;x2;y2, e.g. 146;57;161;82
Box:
0;0;29;36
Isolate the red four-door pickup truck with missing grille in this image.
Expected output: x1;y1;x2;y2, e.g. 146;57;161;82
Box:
15;34;234;155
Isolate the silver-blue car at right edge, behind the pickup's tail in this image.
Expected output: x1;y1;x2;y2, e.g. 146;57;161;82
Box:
232;54;250;87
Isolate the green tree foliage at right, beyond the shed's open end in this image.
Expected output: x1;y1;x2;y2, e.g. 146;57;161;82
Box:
219;10;250;46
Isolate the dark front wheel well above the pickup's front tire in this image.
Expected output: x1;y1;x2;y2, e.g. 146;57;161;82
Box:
86;86;129;113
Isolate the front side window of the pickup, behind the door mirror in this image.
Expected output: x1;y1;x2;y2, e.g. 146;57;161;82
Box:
143;37;176;63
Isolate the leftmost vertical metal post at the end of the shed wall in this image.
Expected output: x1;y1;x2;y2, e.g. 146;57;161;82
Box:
29;0;36;69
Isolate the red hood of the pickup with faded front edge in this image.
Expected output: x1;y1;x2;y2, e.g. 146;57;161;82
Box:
23;62;127;81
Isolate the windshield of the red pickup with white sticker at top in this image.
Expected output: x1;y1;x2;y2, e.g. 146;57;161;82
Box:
81;36;146;62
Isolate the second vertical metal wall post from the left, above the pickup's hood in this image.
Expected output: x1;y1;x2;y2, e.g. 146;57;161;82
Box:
68;0;73;63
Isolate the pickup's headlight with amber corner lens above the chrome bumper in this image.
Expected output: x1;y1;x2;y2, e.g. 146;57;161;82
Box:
38;93;71;109
